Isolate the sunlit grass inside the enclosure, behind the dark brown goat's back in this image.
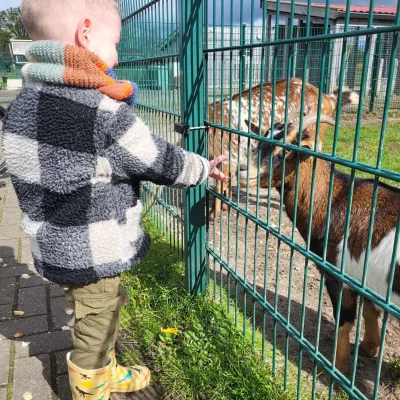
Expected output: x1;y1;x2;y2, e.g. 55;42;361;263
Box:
323;122;400;187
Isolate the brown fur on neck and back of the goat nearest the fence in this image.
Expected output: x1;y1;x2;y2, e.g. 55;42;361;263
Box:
278;159;400;264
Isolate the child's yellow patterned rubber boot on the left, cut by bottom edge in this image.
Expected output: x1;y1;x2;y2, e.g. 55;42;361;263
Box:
67;352;112;400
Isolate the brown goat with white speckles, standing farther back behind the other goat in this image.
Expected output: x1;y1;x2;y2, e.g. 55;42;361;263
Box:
208;78;354;219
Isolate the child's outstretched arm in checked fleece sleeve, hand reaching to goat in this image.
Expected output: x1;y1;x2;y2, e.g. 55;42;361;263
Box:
105;105;228;187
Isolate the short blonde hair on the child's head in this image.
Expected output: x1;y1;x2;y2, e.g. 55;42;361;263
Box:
21;0;119;39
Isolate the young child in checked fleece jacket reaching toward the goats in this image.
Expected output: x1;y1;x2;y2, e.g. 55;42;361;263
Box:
3;0;228;400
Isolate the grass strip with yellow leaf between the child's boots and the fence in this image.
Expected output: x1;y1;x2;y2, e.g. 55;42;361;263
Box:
121;220;302;400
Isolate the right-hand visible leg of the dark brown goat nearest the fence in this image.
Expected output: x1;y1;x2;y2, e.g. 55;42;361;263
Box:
360;299;381;357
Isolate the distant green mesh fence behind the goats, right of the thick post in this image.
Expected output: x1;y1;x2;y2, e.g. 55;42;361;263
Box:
208;24;400;113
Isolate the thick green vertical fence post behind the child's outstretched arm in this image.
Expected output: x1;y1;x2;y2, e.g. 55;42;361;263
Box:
179;0;208;294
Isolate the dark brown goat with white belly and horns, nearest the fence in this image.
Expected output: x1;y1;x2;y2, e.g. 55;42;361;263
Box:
240;110;400;371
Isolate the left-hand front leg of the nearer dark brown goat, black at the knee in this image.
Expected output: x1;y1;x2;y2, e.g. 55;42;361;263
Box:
326;275;357;373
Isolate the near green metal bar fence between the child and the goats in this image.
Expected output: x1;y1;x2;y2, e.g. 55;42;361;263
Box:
117;0;400;399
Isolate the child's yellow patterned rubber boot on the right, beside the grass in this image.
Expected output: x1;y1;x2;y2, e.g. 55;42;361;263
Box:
109;347;150;393
